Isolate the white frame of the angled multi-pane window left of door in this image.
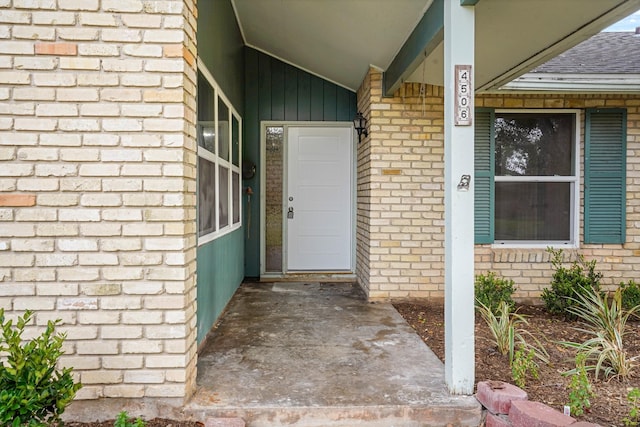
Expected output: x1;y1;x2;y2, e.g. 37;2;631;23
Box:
196;58;243;246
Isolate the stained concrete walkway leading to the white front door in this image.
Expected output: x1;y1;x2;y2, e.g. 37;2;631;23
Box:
186;283;480;427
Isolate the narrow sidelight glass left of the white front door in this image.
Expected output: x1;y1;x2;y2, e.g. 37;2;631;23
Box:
264;126;284;273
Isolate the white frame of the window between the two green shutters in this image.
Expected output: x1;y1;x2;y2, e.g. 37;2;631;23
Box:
492;109;582;249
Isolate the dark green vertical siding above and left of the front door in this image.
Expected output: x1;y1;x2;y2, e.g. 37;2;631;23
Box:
244;48;356;277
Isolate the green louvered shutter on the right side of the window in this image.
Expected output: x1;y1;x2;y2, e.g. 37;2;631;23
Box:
584;108;627;243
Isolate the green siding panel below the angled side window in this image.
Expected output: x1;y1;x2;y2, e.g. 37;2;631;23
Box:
197;229;244;342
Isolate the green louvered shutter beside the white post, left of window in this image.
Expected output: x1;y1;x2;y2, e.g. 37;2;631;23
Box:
474;108;495;244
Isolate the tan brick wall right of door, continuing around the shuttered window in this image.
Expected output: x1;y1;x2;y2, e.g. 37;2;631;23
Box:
357;69;640;299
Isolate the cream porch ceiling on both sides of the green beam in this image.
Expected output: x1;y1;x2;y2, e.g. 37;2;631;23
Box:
232;0;640;90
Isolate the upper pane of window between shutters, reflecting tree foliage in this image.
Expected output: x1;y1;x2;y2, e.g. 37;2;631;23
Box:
495;113;575;176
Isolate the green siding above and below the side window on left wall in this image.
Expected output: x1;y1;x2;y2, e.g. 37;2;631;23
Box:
196;0;245;342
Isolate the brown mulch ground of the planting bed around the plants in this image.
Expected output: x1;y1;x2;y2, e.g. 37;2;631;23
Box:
395;302;640;427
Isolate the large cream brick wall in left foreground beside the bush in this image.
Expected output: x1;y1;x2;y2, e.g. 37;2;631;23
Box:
0;0;196;399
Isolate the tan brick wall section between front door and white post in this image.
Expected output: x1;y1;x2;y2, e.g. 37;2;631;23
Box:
357;69;444;299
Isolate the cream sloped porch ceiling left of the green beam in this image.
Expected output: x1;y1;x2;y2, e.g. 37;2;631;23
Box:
232;0;432;90
